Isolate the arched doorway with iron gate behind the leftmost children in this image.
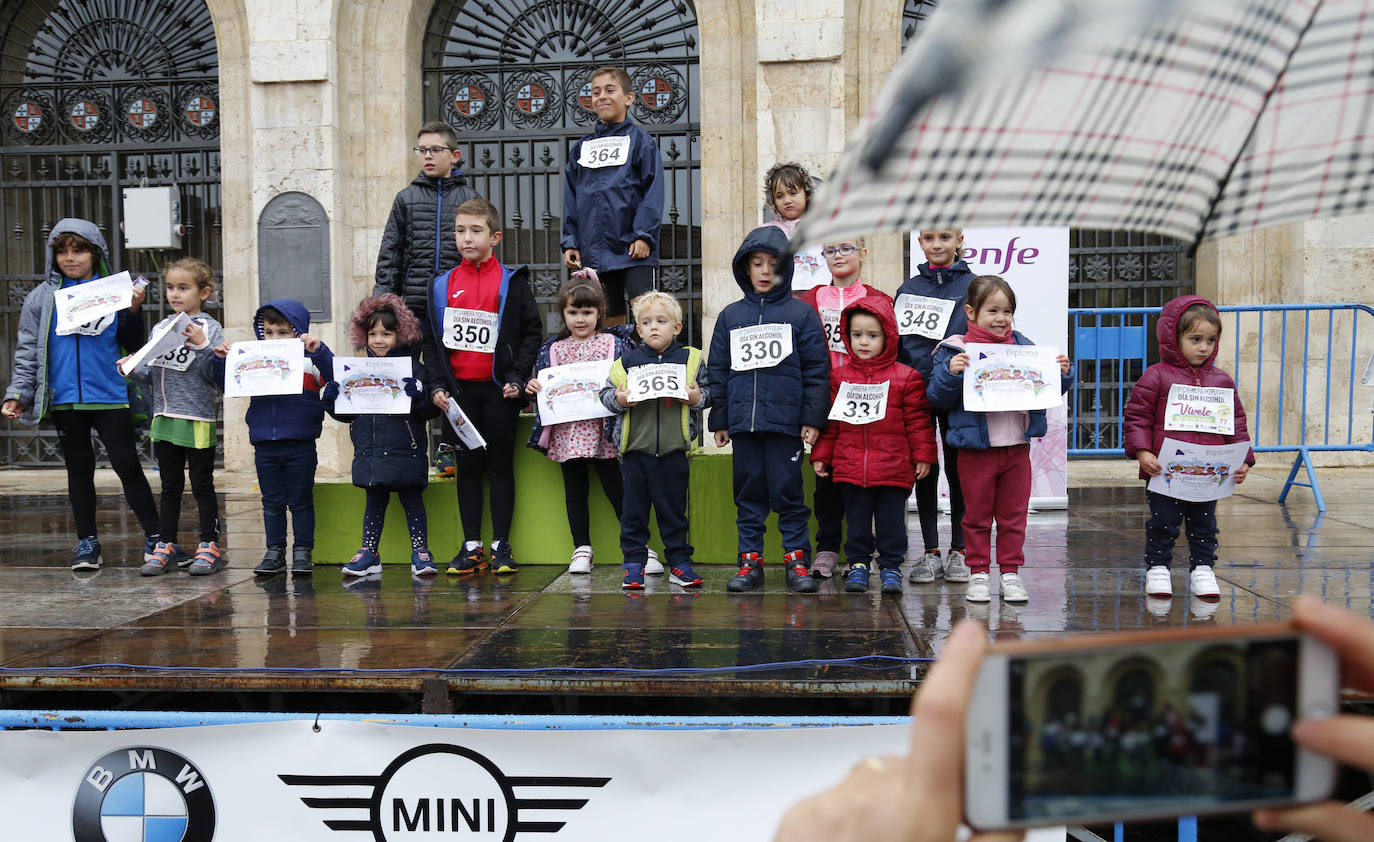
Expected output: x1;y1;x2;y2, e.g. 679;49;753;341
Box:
0;0;223;466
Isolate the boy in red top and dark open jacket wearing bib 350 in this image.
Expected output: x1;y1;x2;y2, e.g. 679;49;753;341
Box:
423;199;544;576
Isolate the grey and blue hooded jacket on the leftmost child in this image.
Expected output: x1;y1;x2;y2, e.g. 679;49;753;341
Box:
4;218;147;424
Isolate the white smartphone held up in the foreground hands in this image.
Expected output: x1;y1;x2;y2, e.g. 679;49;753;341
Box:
965;625;1340;830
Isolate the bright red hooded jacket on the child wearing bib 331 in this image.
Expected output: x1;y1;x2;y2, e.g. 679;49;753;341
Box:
811;295;936;489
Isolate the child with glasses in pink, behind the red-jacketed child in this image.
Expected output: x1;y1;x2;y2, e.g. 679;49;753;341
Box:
783;236;890;578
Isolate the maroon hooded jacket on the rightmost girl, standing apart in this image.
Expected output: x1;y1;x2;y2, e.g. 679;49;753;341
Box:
1125;295;1254;479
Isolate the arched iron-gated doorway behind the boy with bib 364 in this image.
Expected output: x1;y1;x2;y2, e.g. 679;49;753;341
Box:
423;0;702;345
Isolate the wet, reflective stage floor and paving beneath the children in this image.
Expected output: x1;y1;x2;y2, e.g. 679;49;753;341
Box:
0;468;1374;710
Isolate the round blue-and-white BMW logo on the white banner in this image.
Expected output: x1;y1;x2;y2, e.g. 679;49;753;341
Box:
71;746;214;842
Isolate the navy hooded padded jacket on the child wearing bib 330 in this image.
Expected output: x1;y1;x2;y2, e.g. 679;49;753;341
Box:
706;227;830;435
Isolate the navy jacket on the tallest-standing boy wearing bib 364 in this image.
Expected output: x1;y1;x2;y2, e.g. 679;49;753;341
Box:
562;120;664;272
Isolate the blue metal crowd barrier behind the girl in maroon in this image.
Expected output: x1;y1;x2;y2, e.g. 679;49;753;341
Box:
1069;304;1374;511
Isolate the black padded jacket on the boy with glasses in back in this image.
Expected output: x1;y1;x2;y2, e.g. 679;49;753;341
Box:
372;170;477;319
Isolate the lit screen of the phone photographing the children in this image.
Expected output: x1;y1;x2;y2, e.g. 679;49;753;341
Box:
1007;639;1298;820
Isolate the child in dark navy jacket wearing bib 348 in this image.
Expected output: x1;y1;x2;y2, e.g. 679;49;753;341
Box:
897;228;974;584
